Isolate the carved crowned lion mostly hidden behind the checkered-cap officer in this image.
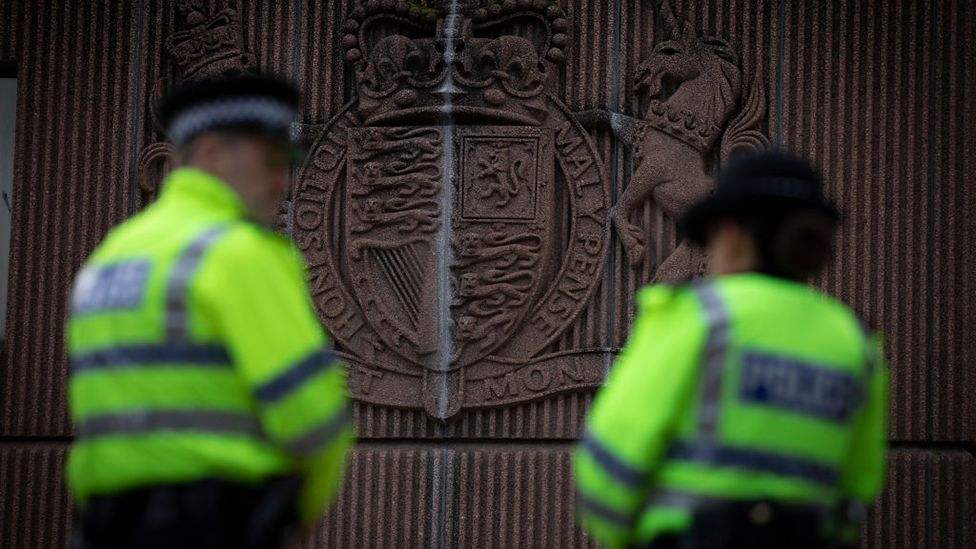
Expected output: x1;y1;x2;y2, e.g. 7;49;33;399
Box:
137;0;257;202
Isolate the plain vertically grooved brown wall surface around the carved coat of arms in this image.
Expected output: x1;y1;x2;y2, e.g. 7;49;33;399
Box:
0;0;976;549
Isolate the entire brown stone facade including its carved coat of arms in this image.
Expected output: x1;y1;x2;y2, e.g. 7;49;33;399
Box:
0;0;976;549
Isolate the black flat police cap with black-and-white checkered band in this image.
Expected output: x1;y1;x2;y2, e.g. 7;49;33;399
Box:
159;74;299;152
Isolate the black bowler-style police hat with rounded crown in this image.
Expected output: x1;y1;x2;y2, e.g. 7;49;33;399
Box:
681;151;840;244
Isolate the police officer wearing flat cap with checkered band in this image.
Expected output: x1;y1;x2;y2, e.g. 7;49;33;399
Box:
67;76;352;549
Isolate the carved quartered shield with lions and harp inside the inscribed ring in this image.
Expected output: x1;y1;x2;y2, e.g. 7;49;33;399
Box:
344;126;554;371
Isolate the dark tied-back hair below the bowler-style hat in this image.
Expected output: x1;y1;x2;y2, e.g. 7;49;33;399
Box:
733;209;837;281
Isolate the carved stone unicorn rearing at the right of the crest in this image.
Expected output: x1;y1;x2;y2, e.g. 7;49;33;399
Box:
580;0;769;282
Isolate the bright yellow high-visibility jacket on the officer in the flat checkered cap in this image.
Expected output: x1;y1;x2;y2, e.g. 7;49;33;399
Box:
67;168;352;522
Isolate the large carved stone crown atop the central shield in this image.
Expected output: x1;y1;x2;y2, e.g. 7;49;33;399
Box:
342;0;568;125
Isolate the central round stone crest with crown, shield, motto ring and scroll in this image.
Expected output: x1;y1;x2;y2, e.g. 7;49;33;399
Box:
292;1;609;419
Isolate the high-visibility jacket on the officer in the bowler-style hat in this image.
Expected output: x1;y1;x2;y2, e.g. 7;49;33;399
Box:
573;273;887;547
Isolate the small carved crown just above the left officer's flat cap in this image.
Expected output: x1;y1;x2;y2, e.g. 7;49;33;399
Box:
166;5;255;79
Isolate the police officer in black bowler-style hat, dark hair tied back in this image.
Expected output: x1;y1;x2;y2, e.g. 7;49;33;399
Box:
573;152;887;549
